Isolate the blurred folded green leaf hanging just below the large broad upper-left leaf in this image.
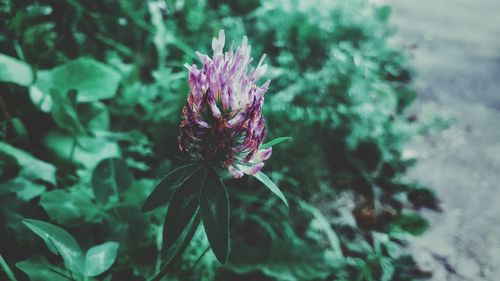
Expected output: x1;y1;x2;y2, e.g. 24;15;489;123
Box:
50;88;86;136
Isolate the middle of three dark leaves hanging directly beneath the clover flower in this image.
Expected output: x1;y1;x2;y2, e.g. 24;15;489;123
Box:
163;166;207;250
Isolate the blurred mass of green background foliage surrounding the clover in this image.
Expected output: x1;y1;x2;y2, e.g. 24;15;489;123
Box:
0;0;446;281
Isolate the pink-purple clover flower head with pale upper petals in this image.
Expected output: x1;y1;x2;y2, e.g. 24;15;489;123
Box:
179;30;272;178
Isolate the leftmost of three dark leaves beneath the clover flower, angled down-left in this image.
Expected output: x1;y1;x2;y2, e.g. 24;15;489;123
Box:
141;163;200;212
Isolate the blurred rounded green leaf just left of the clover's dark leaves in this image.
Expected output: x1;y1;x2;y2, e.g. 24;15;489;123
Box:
91;158;133;206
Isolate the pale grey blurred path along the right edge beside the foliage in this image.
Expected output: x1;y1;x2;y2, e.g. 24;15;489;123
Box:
387;0;500;281
